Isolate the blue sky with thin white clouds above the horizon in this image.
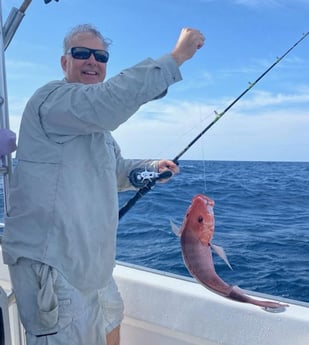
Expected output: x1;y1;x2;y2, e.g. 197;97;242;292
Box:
1;0;309;162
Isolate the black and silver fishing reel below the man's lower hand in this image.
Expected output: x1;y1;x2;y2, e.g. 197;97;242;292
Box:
129;168;173;188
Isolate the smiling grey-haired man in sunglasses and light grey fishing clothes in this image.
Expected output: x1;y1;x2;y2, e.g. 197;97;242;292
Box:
3;25;204;345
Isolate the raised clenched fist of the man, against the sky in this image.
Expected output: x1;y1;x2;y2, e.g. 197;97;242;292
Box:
172;28;205;65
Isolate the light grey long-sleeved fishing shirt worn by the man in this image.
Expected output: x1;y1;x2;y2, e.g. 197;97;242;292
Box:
2;55;181;289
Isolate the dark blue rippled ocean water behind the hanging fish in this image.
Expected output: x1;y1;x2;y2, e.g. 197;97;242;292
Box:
0;160;309;302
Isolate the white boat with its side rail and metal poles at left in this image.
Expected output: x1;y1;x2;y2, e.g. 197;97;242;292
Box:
0;0;309;345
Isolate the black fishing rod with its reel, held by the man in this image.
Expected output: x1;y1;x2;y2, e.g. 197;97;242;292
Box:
119;31;309;219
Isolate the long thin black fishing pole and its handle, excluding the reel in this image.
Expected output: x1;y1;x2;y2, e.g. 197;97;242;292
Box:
119;31;309;219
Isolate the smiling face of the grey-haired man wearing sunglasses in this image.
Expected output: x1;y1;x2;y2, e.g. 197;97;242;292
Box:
61;32;106;84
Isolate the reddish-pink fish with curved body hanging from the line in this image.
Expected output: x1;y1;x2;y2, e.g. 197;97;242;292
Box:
171;194;288;312
